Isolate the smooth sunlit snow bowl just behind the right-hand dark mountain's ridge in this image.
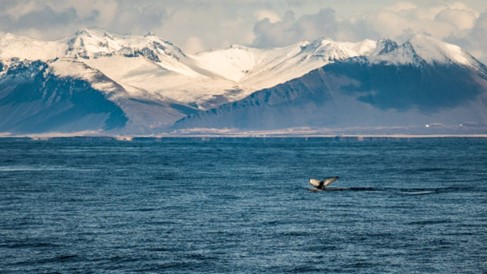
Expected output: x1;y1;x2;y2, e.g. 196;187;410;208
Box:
193;39;375;95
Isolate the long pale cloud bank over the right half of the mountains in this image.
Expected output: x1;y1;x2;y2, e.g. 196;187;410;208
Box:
253;2;487;61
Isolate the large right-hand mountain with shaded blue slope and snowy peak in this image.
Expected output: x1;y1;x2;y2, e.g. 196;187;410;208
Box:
174;35;487;133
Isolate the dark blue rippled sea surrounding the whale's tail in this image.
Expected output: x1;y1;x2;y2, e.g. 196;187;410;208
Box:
0;138;487;273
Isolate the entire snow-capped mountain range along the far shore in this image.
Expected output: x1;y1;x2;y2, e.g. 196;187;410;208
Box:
0;29;487;135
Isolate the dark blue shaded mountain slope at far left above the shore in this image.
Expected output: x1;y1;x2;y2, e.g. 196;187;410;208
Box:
0;61;128;132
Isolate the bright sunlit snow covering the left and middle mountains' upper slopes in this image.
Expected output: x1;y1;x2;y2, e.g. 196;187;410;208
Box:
0;28;375;109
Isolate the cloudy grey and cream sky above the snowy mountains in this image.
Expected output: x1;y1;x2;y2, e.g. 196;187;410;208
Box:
0;0;487;62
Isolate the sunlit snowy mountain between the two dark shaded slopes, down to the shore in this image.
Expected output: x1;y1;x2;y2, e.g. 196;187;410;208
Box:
0;29;374;133
